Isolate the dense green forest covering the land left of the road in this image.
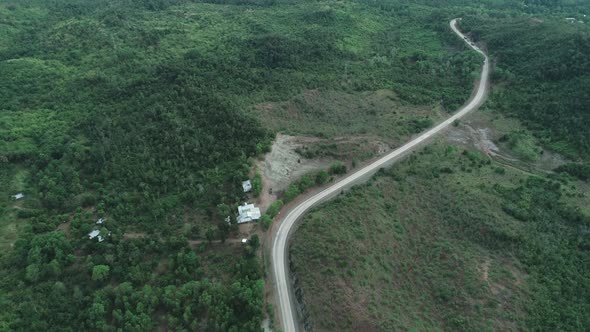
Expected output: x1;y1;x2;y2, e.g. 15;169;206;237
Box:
0;0;488;331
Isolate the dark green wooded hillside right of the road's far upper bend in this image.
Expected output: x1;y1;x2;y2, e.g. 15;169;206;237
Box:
462;12;590;158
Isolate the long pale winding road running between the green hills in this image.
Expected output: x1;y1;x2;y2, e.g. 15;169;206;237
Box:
271;19;490;332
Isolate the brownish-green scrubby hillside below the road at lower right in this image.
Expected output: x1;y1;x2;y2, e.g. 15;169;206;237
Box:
291;144;590;331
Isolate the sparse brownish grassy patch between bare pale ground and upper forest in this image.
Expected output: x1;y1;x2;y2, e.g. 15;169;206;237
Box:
258;90;448;145
